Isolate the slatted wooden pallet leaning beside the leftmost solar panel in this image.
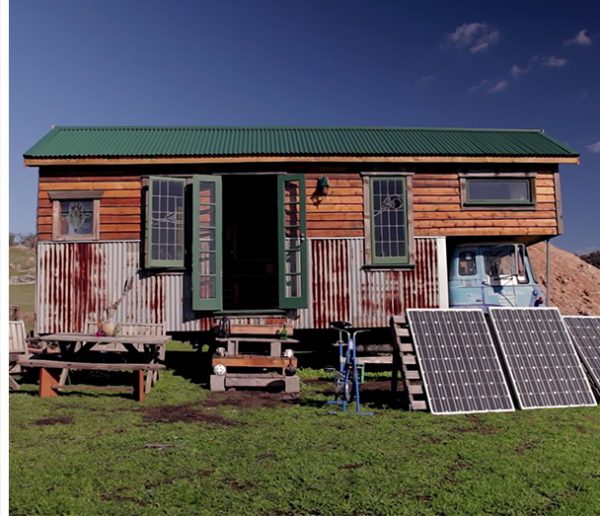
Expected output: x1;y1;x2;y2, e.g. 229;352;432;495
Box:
390;315;428;410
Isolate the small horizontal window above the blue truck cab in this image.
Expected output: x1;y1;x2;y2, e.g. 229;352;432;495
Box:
463;177;534;206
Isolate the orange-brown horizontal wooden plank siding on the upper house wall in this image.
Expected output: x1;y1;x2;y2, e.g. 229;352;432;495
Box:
37;166;561;240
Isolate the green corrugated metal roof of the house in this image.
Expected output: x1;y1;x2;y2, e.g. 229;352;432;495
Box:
24;126;578;159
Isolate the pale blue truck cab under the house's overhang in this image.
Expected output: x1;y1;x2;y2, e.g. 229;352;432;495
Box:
448;242;544;312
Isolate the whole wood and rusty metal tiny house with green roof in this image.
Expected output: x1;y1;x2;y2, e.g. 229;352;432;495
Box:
24;127;579;336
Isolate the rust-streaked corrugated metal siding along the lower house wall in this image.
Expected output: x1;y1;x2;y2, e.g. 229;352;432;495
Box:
36;238;445;334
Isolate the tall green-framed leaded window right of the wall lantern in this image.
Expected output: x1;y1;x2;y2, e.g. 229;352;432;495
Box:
369;176;410;265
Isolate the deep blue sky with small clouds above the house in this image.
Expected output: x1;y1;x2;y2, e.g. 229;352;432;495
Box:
9;0;600;252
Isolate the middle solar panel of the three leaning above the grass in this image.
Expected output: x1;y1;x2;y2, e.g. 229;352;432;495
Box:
490;308;596;409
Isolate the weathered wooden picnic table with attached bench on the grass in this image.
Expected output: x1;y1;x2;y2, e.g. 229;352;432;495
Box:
19;333;169;401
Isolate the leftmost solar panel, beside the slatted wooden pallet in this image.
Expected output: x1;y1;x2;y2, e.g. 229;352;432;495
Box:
407;309;515;414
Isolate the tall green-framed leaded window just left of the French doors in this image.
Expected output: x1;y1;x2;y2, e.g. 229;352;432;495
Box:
146;177;186;268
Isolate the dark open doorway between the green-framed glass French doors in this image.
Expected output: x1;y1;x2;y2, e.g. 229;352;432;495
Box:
223;174;279;310
